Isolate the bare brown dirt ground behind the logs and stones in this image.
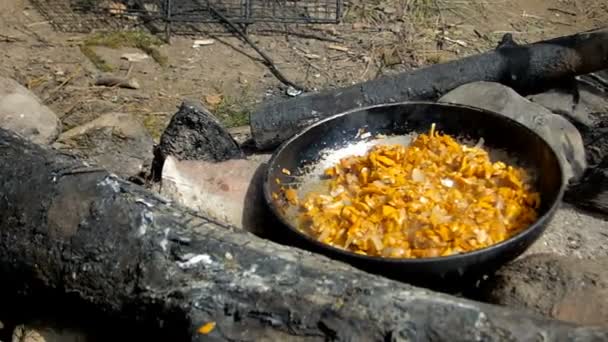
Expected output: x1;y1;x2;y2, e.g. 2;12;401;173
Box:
0;0;608;138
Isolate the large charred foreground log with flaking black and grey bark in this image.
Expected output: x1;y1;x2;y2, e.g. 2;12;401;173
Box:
0;129;608;341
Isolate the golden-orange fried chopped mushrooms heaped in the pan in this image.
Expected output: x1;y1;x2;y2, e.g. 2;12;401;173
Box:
298;125;540;258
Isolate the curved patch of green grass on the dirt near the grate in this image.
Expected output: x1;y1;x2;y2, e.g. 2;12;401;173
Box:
80;31;168;71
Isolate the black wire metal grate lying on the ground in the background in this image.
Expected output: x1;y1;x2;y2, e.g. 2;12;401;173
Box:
31;0;342;32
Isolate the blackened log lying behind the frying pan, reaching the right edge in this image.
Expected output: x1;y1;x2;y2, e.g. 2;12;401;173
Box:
250;29;608;149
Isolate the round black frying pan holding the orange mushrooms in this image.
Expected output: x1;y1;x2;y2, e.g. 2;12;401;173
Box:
264;102;565;289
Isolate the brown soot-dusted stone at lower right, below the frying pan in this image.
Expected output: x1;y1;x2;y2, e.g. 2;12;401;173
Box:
480;254;608;325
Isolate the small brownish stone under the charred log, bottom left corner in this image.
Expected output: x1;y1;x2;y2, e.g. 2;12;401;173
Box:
12;324;90;342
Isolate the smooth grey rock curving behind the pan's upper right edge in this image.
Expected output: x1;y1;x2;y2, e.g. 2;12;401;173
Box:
439;82;587;180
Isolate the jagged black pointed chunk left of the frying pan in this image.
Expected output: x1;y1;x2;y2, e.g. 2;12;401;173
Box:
152;100;244;180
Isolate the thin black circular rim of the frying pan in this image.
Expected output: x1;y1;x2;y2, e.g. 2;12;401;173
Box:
263;101;566;265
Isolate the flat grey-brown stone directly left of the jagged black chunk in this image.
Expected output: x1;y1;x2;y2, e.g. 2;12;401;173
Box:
53;113;154;182
